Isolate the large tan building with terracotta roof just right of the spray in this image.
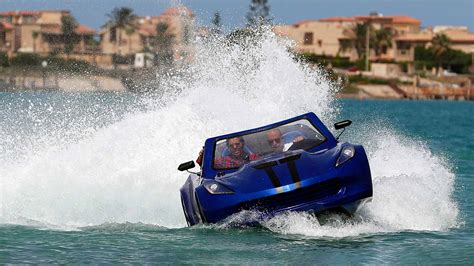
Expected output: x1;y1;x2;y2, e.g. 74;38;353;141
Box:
274;14;421;61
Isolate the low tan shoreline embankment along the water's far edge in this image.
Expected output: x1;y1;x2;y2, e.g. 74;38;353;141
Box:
0;68;474;100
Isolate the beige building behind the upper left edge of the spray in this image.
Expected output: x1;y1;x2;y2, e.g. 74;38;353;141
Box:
99;6;194;59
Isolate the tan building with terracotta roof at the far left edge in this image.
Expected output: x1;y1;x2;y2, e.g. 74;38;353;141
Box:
0;10;95;56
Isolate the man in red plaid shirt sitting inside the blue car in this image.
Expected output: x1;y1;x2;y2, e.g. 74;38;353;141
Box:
214;137;259;169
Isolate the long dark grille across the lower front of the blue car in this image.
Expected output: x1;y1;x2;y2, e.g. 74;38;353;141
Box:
238;178;342;211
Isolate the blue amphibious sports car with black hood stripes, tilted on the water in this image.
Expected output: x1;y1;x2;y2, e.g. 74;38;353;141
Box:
178;113;372;226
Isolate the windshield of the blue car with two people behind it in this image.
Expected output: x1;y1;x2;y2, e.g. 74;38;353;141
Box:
213;119;326;170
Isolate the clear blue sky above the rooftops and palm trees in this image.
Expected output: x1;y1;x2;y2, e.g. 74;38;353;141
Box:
0;0;474;32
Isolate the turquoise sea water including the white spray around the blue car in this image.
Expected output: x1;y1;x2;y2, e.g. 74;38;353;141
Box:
0;30;474;264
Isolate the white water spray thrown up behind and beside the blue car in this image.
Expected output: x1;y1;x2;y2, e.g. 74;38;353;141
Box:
0;28;458;234
